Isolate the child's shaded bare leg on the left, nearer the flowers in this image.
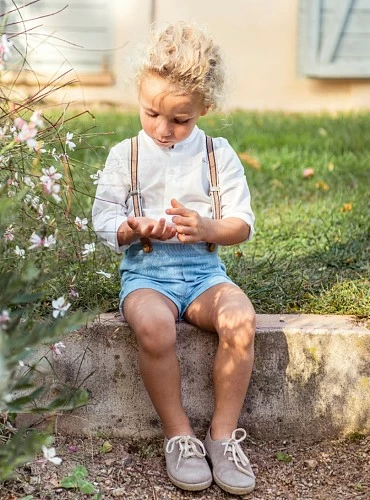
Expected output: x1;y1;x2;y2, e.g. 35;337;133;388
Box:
124;289;193;438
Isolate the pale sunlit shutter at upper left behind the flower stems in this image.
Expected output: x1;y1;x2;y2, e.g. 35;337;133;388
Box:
0;0;114;75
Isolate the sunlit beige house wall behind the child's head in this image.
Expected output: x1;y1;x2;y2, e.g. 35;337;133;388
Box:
27;0;370;112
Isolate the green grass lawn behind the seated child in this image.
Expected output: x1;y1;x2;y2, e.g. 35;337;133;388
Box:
62;111;370;317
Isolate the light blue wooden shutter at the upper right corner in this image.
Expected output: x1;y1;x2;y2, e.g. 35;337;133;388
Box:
298;0;370;78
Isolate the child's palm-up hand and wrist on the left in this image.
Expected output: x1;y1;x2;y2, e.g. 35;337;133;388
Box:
117;217;176;245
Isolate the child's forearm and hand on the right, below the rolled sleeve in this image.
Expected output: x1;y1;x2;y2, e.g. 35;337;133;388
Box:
166;199;250;245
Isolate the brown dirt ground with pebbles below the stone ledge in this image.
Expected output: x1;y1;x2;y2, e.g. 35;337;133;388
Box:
0;434;370;500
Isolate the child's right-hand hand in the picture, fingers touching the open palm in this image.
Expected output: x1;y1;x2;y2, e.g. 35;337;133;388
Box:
166;199;207;243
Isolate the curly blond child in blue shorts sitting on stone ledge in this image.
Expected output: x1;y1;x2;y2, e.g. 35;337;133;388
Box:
93;22;255;495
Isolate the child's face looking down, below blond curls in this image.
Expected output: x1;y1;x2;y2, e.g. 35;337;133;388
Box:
139;74;207;148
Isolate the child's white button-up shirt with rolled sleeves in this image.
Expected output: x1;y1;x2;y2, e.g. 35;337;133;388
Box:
92;123;254;253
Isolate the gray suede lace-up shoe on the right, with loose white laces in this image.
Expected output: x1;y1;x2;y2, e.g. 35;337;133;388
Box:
204;429;256;495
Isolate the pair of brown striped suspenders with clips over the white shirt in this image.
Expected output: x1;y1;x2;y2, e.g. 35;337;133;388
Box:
130;135;221;253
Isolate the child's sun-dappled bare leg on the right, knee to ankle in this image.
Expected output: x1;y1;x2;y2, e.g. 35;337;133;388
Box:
185;283;255;439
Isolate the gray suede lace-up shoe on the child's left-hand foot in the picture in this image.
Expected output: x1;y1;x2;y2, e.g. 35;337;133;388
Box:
163;436;212;491
